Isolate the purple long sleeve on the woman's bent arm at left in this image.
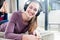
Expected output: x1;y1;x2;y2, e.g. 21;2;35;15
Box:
5;13;22;40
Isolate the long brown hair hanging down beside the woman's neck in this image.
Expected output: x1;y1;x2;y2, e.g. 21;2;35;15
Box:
28;16;37;33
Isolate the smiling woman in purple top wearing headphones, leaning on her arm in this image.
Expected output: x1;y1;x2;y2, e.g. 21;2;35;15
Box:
5;1;41;40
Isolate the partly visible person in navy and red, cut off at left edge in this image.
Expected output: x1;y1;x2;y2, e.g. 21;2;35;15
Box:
0;0;8;25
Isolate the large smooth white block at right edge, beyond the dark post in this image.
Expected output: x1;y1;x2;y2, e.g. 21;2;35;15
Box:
48;10;60;23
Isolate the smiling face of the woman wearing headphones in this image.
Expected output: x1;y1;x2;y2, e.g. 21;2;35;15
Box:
26;2;39;18
